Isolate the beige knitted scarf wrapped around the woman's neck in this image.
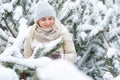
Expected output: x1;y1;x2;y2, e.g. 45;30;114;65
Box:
34;21;62;42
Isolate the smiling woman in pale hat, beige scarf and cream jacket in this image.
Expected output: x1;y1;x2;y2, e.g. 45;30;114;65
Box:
24;1;76;62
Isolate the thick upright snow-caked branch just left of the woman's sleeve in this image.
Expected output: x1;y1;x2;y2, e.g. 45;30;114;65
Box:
1;18;27;58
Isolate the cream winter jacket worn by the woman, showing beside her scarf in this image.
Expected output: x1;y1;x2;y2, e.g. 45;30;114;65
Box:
24;21;76;62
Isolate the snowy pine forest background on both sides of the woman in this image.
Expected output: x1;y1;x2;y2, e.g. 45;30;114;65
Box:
0;0;120;80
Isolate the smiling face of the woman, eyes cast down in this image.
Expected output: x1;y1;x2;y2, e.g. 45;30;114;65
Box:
37;16;55;28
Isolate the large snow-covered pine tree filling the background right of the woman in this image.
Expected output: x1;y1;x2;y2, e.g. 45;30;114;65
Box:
58;0;120;80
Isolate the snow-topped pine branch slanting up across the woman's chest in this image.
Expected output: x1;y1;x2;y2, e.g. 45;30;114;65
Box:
31;38;64;58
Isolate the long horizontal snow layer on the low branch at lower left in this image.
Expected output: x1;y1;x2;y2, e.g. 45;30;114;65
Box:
0;55;51;69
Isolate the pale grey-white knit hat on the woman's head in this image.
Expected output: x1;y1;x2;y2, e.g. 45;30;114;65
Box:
34;1;56;22
